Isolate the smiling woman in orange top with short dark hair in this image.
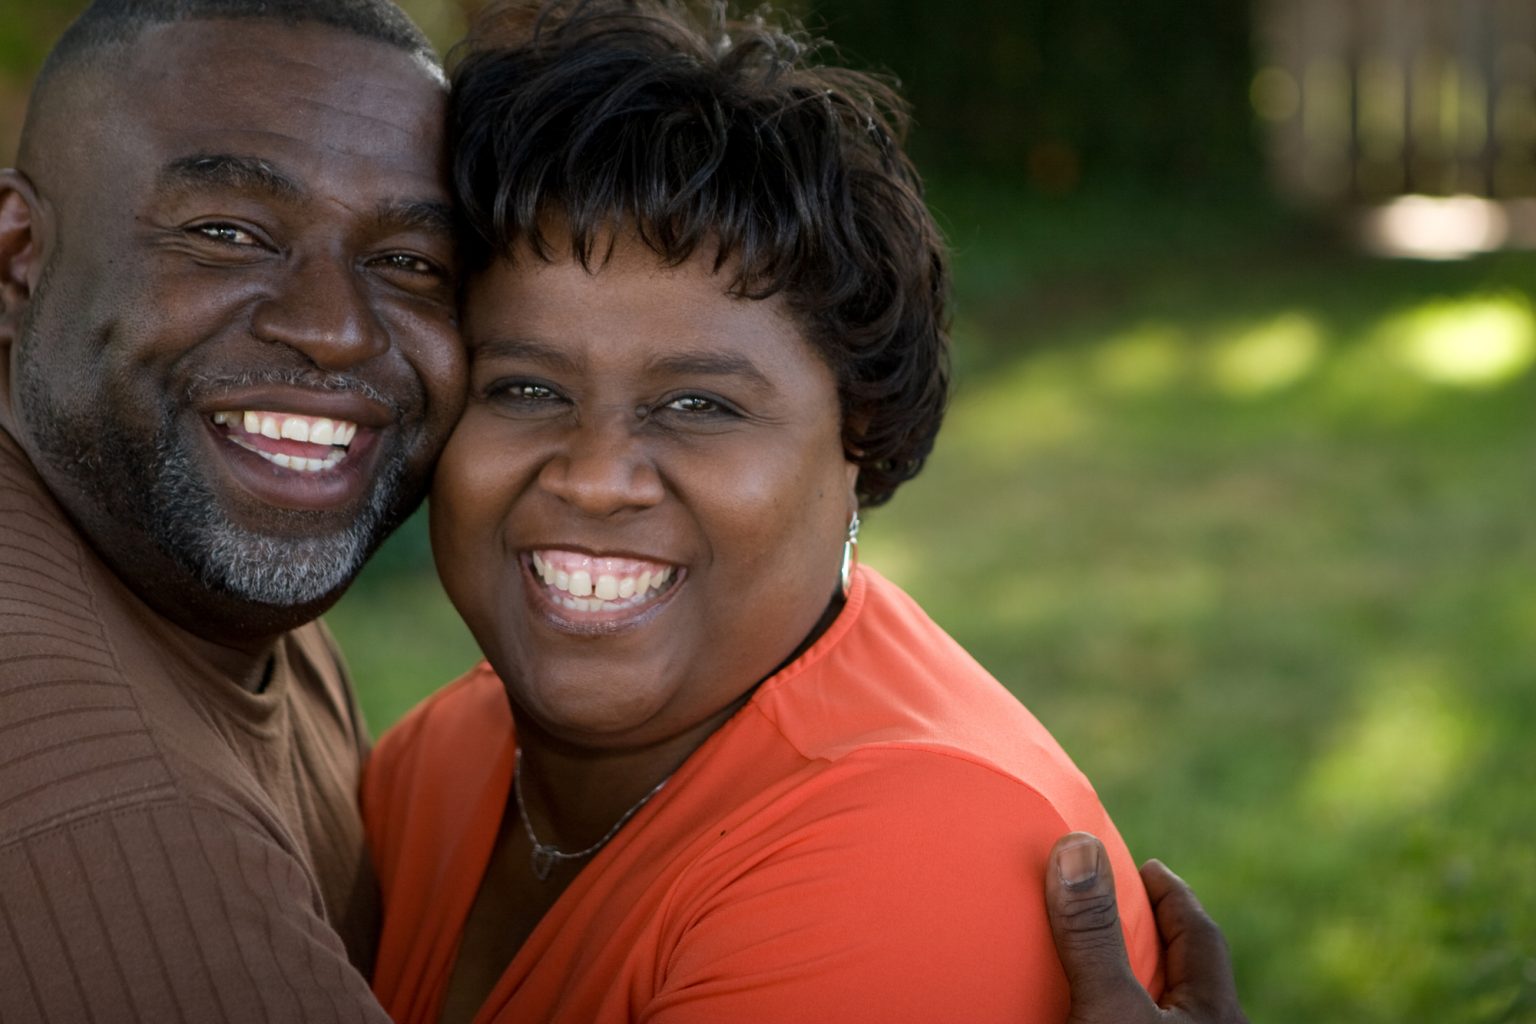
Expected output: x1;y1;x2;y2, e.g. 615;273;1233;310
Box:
364;0;1160;1024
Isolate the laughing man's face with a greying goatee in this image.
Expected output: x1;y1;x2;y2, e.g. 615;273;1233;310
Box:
9;21;464;642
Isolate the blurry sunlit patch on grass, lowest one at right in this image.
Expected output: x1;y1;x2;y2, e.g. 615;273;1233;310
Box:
1307;657;1473;820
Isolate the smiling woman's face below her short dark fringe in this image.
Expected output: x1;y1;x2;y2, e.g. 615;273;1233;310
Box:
432;241;857;749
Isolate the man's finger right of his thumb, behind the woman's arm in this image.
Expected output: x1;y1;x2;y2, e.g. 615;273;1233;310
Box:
1141;860;1247;1024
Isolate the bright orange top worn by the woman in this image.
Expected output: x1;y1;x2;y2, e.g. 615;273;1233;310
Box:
362;570;1161;1024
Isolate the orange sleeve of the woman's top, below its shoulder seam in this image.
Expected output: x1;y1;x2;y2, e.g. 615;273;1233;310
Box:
637;751;1087;1024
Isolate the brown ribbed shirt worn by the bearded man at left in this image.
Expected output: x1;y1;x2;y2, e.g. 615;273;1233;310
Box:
0;431;386;1024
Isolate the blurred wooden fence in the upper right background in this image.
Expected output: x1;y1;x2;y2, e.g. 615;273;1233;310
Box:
1253;0;1536;203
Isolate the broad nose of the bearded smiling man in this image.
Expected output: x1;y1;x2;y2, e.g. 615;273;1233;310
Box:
252;256;390;370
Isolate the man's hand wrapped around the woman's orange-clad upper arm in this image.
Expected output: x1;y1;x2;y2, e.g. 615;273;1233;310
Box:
1046;832;1247;1024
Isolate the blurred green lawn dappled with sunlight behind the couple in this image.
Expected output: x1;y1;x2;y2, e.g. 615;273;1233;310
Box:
332;195;1536;1024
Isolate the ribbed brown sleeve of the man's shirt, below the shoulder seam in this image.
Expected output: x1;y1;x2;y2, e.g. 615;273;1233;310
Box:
0;801;387;1024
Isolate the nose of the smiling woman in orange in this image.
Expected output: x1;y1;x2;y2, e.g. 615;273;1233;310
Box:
539;410;664;516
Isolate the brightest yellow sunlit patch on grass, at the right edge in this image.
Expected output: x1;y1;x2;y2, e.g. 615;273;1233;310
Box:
1381;295;1536;388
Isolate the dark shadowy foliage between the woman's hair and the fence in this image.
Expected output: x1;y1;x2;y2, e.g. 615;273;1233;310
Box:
802;0;1260;195
